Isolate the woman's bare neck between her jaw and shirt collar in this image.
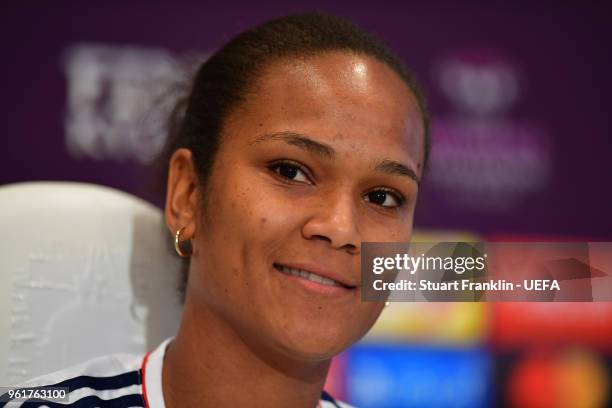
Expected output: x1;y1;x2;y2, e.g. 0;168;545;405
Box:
162;297;330;408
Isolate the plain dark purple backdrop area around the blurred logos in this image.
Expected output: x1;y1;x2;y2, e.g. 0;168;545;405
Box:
0;0;612;239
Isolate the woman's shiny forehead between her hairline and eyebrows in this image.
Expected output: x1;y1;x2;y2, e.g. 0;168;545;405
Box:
227;52;424;170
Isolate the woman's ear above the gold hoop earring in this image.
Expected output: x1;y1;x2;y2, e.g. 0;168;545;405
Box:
164;148;198;241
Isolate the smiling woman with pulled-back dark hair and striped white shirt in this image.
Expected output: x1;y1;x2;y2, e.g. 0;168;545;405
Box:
4;14;428;408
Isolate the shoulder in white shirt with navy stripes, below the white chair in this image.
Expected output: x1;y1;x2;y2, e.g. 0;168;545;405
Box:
4;354;143;407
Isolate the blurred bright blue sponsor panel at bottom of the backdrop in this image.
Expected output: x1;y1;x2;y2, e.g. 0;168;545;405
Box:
346;345;492;408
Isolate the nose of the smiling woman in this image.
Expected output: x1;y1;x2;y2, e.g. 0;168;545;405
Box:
302;192;361;254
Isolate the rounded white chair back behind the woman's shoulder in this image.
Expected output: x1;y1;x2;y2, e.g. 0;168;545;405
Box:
0;182;182;385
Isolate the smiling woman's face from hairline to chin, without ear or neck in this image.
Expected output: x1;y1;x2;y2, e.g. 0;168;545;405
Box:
187;52;424;361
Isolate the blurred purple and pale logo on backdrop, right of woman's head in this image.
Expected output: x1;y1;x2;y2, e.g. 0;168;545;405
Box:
429;50;552;212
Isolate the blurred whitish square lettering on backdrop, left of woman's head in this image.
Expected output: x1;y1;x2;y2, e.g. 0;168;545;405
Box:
64;44;196;163
